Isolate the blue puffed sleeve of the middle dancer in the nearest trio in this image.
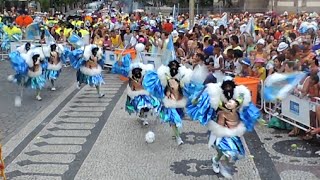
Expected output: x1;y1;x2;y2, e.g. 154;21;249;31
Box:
142;71;164;99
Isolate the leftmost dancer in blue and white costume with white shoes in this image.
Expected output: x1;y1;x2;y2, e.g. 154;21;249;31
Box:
8;48;46;106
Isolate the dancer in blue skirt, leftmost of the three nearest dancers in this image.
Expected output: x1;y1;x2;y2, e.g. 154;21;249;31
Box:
126;63;161;126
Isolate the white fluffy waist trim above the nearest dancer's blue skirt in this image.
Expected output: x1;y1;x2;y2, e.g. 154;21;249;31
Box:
208;121;246;137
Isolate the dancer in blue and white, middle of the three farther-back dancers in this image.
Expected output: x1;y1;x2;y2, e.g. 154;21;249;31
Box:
45;43;66;91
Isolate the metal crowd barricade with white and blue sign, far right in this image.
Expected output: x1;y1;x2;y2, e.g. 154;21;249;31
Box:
263;94;320;131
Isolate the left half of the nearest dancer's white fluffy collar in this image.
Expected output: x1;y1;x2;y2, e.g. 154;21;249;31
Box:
206;83;223;110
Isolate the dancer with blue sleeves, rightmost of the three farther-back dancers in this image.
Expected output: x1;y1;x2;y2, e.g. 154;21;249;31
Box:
69;44;104;98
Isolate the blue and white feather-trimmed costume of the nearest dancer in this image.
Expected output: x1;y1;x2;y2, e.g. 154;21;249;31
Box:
186;83;260;161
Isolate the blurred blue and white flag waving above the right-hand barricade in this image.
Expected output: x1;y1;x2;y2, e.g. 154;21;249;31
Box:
263;72;306;102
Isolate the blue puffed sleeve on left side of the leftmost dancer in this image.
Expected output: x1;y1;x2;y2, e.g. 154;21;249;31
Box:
9;51;28;75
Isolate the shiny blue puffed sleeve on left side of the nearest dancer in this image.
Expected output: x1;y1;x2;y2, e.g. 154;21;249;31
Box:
186;92;216;126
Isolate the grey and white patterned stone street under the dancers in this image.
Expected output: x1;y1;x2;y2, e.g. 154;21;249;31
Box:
0;62;320;180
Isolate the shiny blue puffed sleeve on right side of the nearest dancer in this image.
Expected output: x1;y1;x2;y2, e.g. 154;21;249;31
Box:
240;102;261;132
